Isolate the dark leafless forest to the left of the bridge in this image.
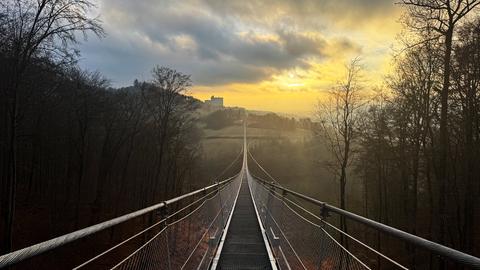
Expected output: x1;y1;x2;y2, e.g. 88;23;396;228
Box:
0;0;244;268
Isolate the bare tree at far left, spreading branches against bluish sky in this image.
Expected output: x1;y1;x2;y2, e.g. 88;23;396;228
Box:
0;0;103;252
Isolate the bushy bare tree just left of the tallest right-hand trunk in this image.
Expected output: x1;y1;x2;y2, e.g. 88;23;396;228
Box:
388;42;441;268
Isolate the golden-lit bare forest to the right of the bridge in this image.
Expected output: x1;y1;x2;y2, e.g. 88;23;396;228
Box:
253;1;480;269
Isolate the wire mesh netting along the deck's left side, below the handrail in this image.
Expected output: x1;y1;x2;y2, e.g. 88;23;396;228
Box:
79;176;241;270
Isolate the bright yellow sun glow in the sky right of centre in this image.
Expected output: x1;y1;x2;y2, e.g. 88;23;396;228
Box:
191;3;399;116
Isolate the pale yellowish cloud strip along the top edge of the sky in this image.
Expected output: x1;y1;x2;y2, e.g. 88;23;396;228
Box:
201;0;396;28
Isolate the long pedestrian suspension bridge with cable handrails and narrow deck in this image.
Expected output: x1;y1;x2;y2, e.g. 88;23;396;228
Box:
0;127;480;270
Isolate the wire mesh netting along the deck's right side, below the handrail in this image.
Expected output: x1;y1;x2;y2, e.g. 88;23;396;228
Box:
249;173;369;270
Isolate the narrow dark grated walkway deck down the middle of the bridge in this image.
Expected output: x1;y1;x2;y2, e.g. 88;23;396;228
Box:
217;174;272;269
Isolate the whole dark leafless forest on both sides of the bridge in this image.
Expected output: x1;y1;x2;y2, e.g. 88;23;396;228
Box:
0;0;480;269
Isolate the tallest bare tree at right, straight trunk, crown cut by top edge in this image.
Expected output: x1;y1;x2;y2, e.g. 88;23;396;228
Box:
401;0;480;249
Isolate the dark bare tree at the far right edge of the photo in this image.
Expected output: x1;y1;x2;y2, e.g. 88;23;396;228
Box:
451;19;480;253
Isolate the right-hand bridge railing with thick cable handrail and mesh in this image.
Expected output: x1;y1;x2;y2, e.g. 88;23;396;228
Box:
250;173;480;269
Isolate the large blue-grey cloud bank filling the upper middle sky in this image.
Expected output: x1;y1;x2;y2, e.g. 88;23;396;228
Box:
80;0;398;86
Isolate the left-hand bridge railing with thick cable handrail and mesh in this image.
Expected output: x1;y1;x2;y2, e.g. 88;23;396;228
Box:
0;175;241;270
